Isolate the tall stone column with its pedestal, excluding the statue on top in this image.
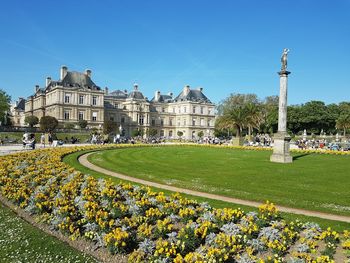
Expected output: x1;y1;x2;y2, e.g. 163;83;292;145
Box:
270;70;293;163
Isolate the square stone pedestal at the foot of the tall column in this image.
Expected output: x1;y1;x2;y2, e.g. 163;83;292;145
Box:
270;132;293;163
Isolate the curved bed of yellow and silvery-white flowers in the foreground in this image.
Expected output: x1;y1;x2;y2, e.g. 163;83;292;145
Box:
0;145;350;262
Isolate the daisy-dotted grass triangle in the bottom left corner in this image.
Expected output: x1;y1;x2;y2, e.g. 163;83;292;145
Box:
0;203;98;263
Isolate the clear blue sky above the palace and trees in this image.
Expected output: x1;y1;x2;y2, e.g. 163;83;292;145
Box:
0;0;350;104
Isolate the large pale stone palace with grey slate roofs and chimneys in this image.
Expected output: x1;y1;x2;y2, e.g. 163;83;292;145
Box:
25;66;215;139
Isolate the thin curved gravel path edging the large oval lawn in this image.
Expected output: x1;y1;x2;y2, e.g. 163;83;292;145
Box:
78;153;350;223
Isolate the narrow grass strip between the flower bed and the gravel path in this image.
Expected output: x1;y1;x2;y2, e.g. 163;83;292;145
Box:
63;151;349;231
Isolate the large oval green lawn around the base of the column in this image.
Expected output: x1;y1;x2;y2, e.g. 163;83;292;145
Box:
89;146;350;215
